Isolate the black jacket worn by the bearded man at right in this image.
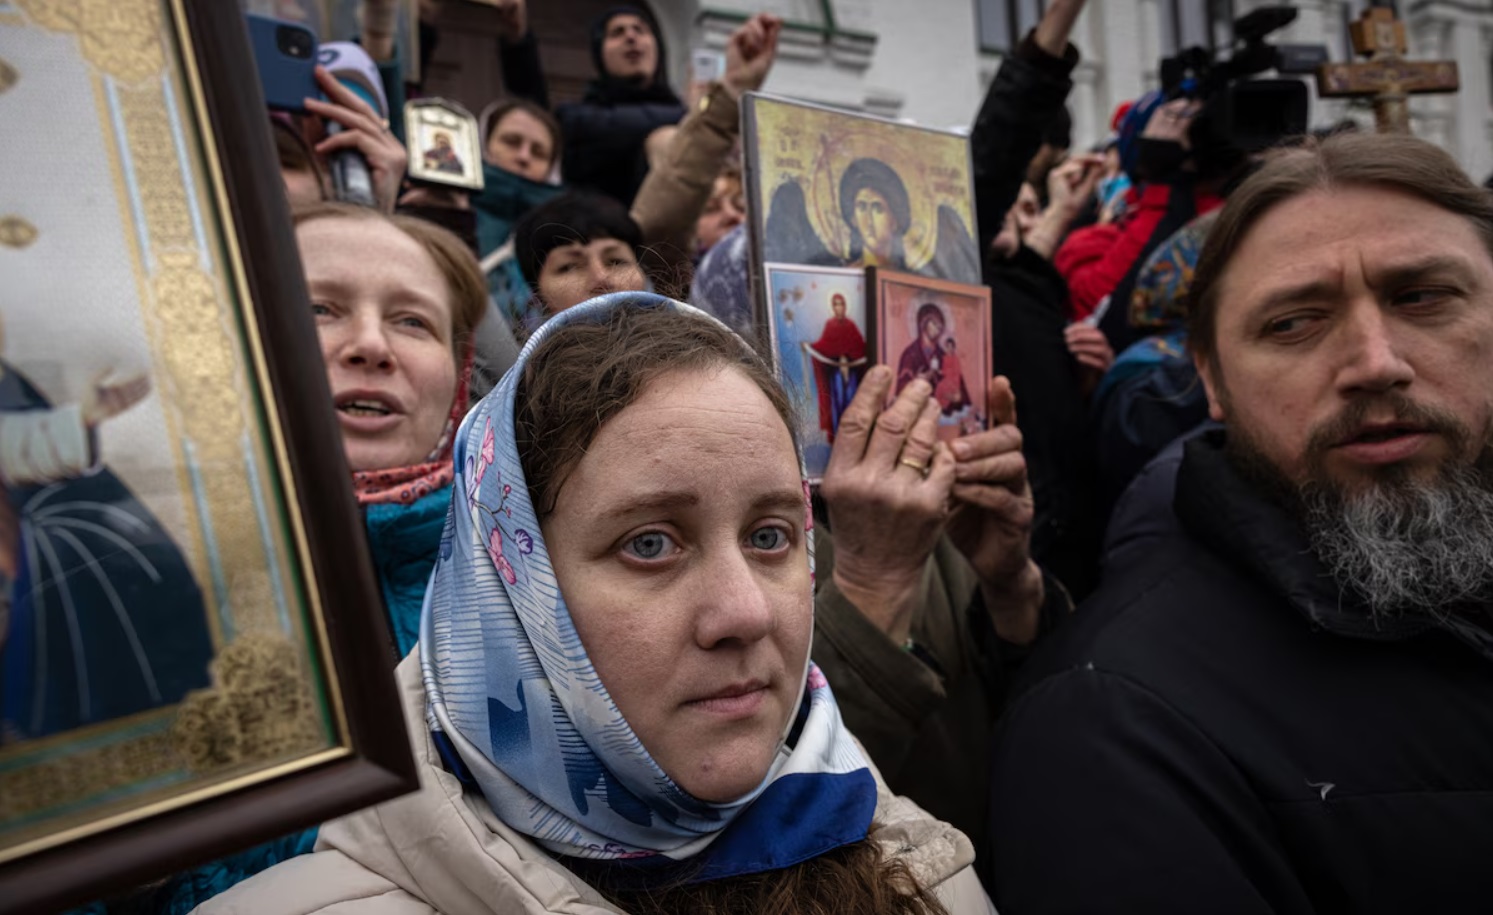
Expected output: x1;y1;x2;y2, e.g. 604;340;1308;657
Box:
991;433;1493;915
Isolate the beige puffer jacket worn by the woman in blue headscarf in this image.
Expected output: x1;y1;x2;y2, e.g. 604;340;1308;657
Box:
196;651;994;915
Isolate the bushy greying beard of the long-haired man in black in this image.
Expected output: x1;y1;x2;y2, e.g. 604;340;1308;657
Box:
1229;406;1493;618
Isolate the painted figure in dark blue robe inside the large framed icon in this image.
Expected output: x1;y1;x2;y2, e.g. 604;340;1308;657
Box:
0;361;212;743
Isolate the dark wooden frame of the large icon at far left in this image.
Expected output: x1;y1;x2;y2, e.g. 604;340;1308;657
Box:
0;0;418;912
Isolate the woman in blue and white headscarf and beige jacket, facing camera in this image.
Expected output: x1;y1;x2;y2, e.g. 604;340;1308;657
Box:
205;293;991;915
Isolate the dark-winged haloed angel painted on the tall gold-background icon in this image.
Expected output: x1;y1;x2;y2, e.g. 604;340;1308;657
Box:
763;157;979;282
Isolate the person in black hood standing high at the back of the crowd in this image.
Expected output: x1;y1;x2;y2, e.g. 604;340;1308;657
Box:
555;6;684;206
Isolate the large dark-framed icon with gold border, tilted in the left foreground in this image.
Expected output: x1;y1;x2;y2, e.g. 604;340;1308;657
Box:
0;0;417;911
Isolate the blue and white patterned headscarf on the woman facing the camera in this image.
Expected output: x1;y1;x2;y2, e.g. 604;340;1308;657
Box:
420;293;876;881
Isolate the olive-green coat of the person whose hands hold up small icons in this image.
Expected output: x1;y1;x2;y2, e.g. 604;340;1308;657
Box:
814;527;1072;887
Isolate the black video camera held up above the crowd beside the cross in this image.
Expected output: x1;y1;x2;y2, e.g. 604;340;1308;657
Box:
1162;6;1327;152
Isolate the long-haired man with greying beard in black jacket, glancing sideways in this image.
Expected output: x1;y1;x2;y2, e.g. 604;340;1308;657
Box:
991;136;1493;915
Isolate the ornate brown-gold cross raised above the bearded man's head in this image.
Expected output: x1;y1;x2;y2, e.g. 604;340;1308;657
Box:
1317;6;1459;133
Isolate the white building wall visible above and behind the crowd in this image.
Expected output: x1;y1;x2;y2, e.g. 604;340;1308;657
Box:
671;0;1493;174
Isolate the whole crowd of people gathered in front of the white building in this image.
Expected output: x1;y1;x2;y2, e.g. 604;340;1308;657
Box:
81;0;1493;915
